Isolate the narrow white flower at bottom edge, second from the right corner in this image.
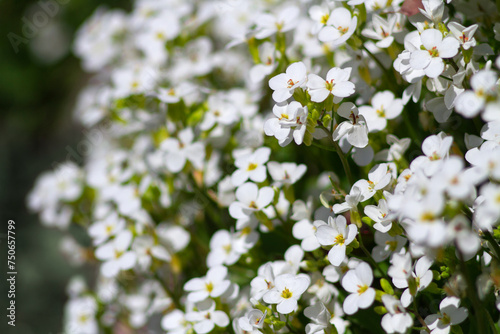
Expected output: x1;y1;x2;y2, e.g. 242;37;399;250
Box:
382;294;413;334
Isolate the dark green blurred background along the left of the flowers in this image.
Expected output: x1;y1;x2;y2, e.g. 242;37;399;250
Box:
0;0;130;334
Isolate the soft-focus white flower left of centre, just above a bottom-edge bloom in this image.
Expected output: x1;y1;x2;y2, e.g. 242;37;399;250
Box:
184;266;231;302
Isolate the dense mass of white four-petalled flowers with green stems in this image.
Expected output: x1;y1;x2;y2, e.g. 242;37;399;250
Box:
28;0;500;334
